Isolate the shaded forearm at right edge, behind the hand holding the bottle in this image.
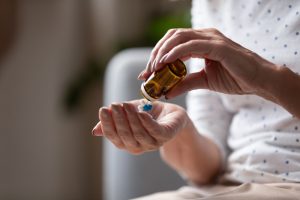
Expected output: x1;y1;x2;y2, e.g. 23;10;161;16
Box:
264;67;300;119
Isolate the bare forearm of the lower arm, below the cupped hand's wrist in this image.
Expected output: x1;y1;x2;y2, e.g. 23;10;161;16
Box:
160;115;221;184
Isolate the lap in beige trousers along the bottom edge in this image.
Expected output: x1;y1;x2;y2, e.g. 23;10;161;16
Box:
134;183;300;200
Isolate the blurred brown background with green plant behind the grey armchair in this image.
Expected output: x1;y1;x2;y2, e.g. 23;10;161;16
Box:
0;0;191;200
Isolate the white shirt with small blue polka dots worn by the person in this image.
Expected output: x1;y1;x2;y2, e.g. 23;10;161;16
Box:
187;0;300;183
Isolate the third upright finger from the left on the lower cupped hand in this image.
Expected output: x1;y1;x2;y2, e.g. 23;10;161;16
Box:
123;103;157;149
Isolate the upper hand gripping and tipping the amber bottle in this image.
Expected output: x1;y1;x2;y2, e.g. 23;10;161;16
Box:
139;29;277;99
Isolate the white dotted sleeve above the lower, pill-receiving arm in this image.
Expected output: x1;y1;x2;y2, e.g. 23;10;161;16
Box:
186;59;232;168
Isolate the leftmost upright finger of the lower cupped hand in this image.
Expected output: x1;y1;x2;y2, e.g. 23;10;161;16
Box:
99;108;125;149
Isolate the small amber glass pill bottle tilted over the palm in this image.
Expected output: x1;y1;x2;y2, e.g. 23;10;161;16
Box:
141;59;187;101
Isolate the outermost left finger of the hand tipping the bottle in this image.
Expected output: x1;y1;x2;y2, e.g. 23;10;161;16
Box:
139;29;177;80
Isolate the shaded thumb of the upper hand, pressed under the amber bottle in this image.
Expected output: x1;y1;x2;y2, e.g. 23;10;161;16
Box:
166;69;208;99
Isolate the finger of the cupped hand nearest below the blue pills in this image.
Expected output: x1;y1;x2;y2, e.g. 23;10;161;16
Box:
138;112;169;141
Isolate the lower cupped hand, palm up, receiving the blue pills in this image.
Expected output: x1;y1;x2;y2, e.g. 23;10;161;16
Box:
93;100;188;154
